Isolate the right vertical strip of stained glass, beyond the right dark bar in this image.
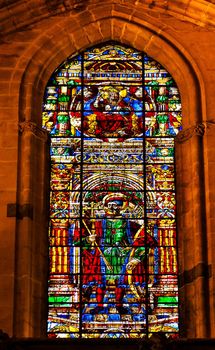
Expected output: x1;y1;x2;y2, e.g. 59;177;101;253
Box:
144;55;181;336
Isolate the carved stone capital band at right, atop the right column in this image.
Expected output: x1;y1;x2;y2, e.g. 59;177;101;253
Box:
175;120;215;143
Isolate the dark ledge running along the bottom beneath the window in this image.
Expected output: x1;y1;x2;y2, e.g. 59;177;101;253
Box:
0;334;215;350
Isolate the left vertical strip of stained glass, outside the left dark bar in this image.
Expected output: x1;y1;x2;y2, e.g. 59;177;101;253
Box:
43;56;82;337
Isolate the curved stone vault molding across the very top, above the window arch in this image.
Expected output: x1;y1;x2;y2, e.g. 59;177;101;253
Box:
0;0;215;37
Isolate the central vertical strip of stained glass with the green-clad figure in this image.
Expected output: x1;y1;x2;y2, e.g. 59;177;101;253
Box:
82;45;146;338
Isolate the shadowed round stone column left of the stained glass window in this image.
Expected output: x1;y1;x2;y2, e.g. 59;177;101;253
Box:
14;122;50;337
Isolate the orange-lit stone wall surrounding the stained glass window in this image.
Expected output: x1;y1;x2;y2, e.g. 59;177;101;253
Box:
0;0;215;338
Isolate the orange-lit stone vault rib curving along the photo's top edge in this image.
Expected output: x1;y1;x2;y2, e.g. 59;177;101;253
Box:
2;0;214;34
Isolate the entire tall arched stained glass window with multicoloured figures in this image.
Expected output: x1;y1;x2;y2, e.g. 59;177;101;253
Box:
42;43;181;338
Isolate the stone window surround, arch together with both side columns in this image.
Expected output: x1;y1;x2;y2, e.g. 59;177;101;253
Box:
14;14;209;337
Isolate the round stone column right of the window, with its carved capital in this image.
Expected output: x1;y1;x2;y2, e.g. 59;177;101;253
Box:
176;123;210;338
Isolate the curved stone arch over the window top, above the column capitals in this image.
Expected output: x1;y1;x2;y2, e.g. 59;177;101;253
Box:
17;14;205;126
